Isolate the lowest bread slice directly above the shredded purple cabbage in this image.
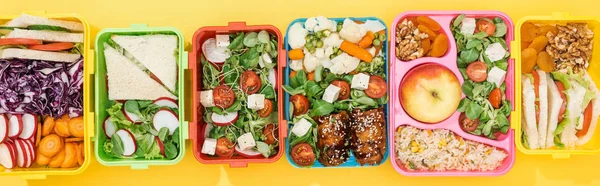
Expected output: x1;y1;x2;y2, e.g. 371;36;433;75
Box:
0;48;81;63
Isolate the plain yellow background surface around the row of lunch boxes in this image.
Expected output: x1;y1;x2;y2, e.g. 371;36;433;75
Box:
0;0;600;186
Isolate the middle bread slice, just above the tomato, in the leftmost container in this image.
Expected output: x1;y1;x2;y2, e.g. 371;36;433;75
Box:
6;28;83;43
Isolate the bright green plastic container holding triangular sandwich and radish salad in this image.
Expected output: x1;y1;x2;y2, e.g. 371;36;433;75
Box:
94;24;188;169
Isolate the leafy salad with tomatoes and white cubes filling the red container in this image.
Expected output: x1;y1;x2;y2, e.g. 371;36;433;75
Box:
200;30;279;159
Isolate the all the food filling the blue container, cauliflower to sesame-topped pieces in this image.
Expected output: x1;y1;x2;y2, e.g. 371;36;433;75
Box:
283;16;389;167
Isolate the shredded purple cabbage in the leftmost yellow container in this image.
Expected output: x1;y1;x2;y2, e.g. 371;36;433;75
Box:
0;58;83;118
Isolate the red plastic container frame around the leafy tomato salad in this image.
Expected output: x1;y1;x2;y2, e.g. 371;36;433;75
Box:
188;22;287;168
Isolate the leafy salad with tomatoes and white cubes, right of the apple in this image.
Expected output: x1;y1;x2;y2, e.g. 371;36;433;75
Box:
451;14;512;139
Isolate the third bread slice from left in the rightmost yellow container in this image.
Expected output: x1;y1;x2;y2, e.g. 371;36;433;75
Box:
546;74;567;148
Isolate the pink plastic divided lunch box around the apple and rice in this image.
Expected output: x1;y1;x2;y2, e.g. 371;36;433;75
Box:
388;11;519;176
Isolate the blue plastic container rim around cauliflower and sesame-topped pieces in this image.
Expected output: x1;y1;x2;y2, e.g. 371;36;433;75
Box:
282;17;394;168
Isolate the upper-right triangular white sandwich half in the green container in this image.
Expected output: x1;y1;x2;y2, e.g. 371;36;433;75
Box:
112;34;178;92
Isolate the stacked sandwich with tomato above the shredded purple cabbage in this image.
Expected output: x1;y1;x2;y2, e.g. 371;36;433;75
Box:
0;14;84;63
